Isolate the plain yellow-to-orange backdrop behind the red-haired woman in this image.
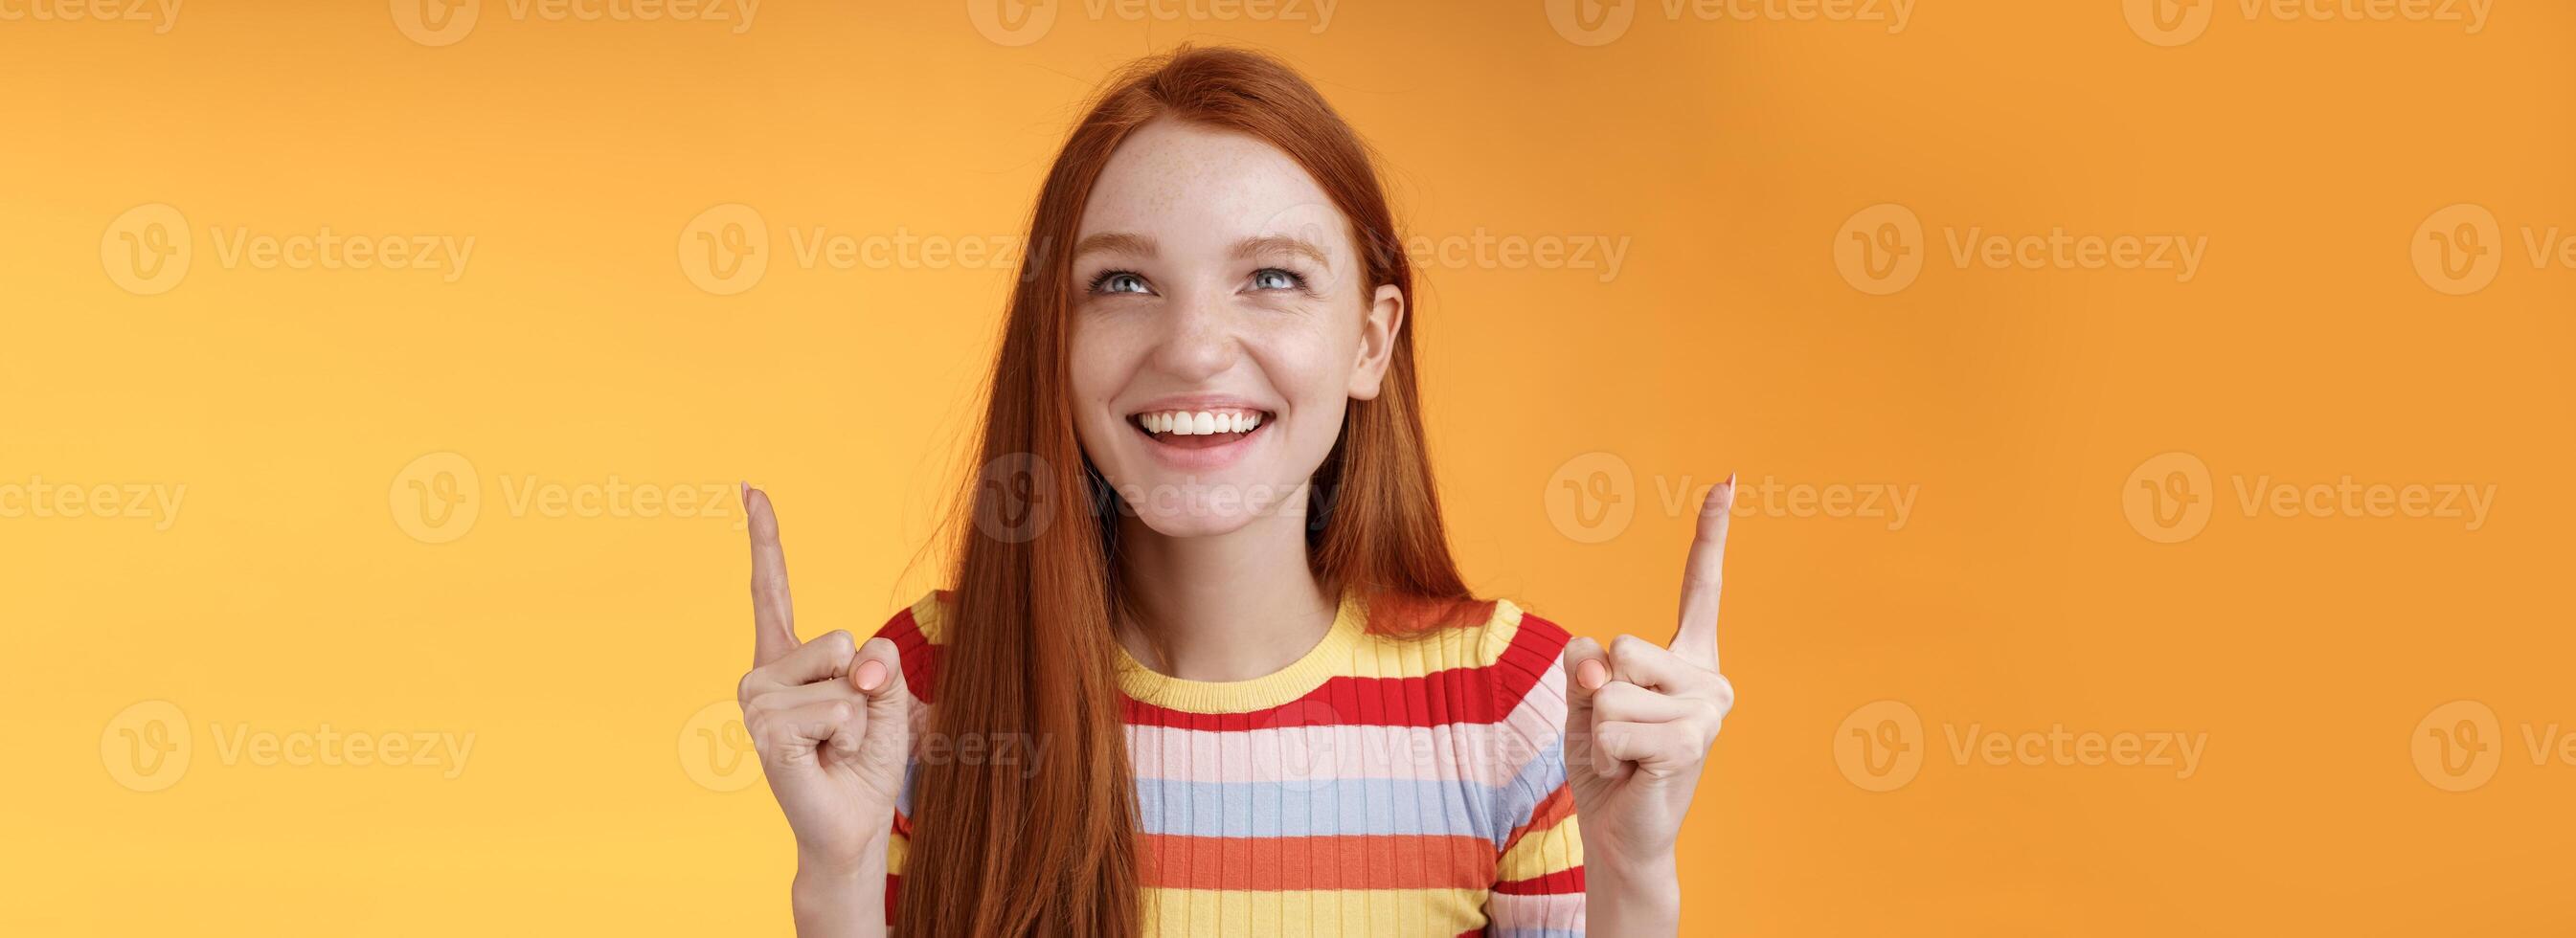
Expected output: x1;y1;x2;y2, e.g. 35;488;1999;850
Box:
0;0;2576;935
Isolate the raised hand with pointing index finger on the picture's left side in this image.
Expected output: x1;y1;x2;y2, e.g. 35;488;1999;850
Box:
736;484;912;881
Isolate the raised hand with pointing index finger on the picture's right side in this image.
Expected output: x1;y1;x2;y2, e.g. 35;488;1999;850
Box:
1564;477;1736;879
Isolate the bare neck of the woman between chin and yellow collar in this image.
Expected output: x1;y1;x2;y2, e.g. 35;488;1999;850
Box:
1118;497;1342;681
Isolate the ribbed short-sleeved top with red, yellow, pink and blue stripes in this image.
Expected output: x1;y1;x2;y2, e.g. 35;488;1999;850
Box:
878;592;1584;938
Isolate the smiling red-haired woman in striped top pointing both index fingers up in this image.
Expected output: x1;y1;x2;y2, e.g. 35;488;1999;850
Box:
739;49;1733;938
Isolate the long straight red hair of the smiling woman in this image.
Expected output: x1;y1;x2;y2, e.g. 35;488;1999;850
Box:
916;46;1489;938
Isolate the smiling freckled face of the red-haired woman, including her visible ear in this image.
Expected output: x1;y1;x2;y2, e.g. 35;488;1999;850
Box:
1072;122;1404;536
